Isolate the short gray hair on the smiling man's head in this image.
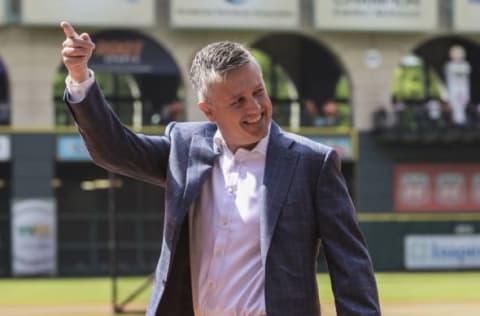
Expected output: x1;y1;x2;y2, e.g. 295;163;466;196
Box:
190;41;256;102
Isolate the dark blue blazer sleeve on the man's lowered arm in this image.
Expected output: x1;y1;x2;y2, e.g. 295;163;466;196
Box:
316;150;380;315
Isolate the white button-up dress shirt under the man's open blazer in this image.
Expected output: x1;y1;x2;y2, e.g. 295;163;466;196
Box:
190;130;268;316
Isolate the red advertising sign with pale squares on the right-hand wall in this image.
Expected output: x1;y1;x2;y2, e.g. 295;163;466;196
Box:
394;164;480;211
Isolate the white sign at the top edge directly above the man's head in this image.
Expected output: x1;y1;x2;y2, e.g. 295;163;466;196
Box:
170;0;300;29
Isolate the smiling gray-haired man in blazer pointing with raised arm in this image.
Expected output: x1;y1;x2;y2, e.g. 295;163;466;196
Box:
62;22;380;316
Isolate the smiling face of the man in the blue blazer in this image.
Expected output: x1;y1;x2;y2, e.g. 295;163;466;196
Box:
198;62;272;152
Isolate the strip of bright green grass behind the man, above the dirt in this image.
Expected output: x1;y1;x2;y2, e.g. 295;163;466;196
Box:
0;272;480;305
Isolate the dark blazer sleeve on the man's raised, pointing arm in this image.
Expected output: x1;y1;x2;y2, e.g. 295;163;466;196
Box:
64;83;174;186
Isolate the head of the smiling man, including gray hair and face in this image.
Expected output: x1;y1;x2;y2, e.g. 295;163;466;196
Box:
190;42;272;152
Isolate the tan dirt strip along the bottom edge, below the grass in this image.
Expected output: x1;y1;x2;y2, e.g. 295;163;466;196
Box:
0;301;480;316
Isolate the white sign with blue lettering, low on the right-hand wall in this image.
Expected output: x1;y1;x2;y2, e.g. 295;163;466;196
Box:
404;235;480;269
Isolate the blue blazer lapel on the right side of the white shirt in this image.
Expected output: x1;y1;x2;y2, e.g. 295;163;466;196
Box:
260;122;298;264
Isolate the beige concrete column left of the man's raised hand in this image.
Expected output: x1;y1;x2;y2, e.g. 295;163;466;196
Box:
0;28;63;128
